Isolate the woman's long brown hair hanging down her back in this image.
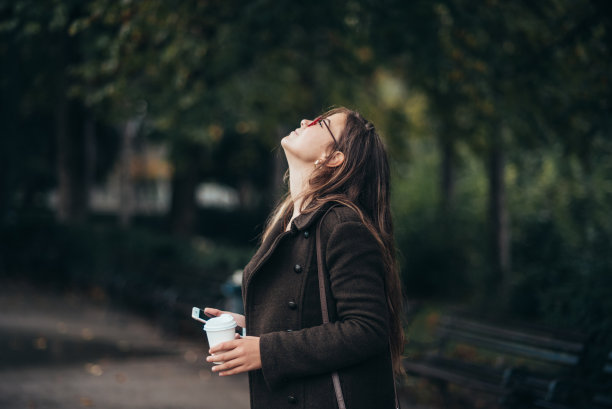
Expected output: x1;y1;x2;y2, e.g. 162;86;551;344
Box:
262;107;404;374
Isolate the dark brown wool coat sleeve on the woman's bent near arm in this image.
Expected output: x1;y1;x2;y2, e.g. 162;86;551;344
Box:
260;221;389;389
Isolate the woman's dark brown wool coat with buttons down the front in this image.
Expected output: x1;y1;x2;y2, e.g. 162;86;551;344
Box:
242;205;394;409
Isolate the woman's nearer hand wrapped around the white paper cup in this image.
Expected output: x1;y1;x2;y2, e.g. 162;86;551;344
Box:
206;334;261;376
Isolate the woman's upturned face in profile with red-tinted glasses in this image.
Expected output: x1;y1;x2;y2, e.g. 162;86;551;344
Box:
281;113;346;166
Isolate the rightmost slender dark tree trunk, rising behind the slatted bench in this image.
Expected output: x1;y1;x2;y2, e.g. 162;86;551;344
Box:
489;128;510;306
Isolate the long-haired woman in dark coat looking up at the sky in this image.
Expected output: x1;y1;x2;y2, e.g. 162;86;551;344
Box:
205;108;403;409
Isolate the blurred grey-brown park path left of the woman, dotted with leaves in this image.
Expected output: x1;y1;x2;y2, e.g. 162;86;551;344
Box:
0;282;249;409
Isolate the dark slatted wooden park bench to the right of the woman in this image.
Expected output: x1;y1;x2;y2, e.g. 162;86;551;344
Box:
404;315;586;409
